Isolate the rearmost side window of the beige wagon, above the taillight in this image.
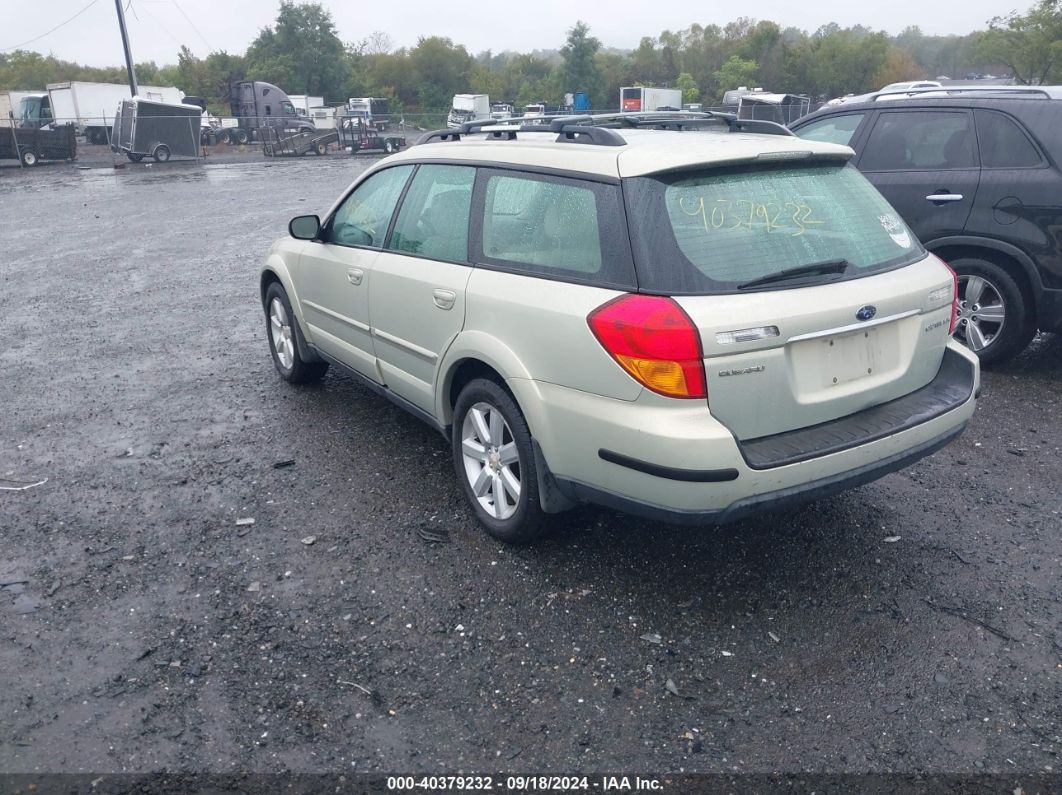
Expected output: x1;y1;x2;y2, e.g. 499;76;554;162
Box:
478;171;634;288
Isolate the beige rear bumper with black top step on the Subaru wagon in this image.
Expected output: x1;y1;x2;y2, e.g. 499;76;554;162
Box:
511;342;978;524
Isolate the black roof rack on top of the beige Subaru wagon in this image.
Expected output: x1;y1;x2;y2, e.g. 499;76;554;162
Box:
413;110;793;146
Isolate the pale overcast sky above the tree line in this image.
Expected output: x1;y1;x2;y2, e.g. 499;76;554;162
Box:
0;0;1006;66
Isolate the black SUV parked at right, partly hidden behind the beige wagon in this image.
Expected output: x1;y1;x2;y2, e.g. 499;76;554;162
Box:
791;92;1062;364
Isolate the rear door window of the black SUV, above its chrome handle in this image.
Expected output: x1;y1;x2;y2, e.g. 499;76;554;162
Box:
859;110;977;171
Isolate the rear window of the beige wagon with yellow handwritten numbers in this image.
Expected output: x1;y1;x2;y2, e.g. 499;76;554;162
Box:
626;163;924;294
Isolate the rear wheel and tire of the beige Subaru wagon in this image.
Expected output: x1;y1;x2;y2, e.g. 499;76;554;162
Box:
451;378;546;545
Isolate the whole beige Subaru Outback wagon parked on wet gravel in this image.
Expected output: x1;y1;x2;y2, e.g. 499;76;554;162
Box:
260;115;978;542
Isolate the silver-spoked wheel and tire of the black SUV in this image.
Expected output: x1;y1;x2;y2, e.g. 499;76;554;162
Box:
948;257;1037;366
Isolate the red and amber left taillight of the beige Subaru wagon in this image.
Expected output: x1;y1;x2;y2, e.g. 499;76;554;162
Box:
586;293;708;398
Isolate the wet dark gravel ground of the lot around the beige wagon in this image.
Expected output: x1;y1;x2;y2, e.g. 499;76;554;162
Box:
0;156;1062;792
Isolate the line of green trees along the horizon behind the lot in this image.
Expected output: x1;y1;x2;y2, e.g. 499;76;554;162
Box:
0;0;1062;114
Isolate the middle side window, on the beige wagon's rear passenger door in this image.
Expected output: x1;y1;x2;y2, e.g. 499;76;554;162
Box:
388;166;476;262
